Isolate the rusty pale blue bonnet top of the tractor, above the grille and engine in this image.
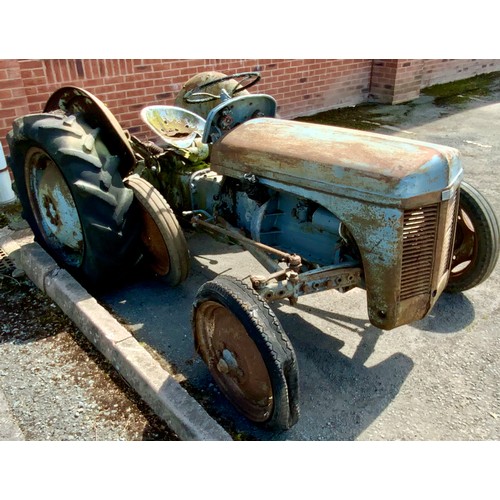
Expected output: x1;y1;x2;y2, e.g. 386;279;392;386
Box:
211;118;462;205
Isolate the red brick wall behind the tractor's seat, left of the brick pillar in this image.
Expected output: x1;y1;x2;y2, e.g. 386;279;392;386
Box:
0;59;371;156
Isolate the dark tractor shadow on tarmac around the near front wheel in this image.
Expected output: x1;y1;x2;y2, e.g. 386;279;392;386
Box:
99;242;413;440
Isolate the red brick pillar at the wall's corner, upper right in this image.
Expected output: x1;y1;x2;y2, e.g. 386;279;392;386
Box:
370;59;424;104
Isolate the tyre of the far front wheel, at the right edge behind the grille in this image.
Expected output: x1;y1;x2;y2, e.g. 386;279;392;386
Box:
446;182;500;293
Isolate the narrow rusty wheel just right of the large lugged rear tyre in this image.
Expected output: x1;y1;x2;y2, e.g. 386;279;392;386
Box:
124;175;190;286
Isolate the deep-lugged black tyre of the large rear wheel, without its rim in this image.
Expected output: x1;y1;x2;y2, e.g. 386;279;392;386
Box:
7;112;140;290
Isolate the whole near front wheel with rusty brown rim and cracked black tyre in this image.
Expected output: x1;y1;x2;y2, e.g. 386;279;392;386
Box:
193;276;299;430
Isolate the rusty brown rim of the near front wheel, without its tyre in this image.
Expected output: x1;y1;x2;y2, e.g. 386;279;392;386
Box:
195;301;273;422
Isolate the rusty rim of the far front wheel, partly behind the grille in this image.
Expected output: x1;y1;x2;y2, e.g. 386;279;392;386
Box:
450;209;478;279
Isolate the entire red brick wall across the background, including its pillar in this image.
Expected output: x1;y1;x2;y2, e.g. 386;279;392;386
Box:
0;59;500;154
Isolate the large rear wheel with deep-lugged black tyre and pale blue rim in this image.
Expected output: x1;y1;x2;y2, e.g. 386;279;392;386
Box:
7;112;140;289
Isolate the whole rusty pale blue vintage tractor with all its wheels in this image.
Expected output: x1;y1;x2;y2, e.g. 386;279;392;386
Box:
4;73;499;429
